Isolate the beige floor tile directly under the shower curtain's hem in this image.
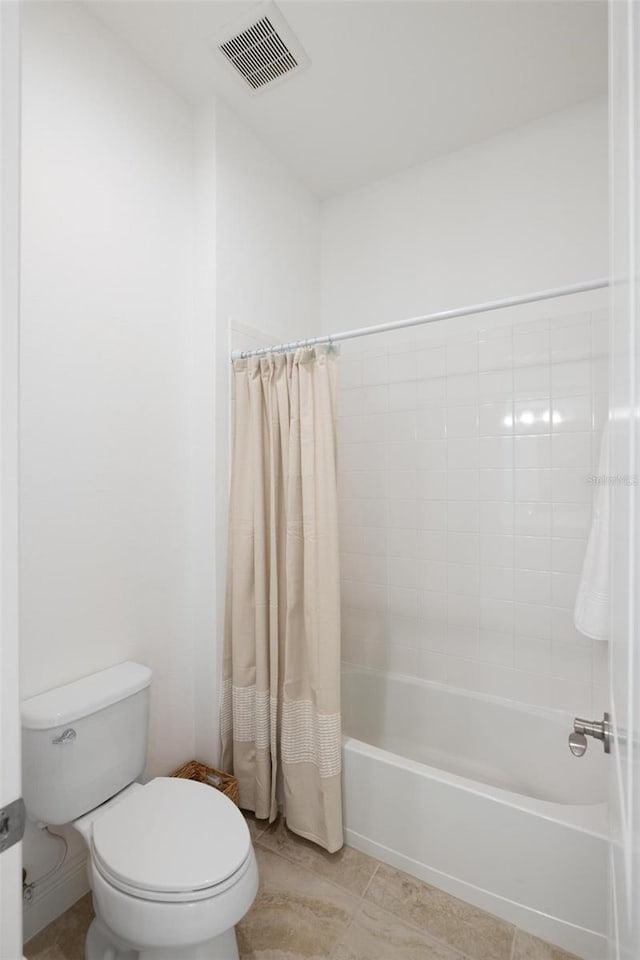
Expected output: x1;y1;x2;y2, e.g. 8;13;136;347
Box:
258;817;378;897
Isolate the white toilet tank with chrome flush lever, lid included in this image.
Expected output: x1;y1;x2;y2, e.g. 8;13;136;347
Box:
22;661;151;824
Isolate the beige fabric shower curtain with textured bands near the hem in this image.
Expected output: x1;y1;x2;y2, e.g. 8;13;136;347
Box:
221;348;343;851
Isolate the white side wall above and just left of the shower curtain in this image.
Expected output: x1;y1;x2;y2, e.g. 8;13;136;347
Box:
215;104;320;760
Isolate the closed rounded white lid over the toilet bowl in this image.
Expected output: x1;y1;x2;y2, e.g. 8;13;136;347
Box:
92;777;251;893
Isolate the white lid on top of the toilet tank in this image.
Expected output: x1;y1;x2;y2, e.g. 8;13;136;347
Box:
22;660;151;730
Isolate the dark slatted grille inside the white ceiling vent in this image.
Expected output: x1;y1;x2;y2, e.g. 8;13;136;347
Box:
219;17;298;90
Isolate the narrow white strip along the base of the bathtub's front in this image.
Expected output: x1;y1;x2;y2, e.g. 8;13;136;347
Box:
344;829;607;960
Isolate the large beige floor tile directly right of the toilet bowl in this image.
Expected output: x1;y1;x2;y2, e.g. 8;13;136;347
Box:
236;846;359;960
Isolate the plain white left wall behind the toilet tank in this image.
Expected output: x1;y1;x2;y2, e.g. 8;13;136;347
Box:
21;3;204;932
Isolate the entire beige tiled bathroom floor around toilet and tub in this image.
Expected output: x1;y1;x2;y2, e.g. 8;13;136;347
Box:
25;816;576;960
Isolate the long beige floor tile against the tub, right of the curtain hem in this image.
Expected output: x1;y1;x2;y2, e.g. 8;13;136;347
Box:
366;864;515;960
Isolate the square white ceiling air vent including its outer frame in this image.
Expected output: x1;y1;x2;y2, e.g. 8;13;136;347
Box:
216;3;309;93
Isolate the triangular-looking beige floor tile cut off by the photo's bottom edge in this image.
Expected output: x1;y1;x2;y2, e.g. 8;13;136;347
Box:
332;902;468;960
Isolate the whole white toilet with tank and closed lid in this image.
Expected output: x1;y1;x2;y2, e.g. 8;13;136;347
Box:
22;662;258;960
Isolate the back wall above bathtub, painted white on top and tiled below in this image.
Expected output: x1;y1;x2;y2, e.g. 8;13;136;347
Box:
322;102;607;712
